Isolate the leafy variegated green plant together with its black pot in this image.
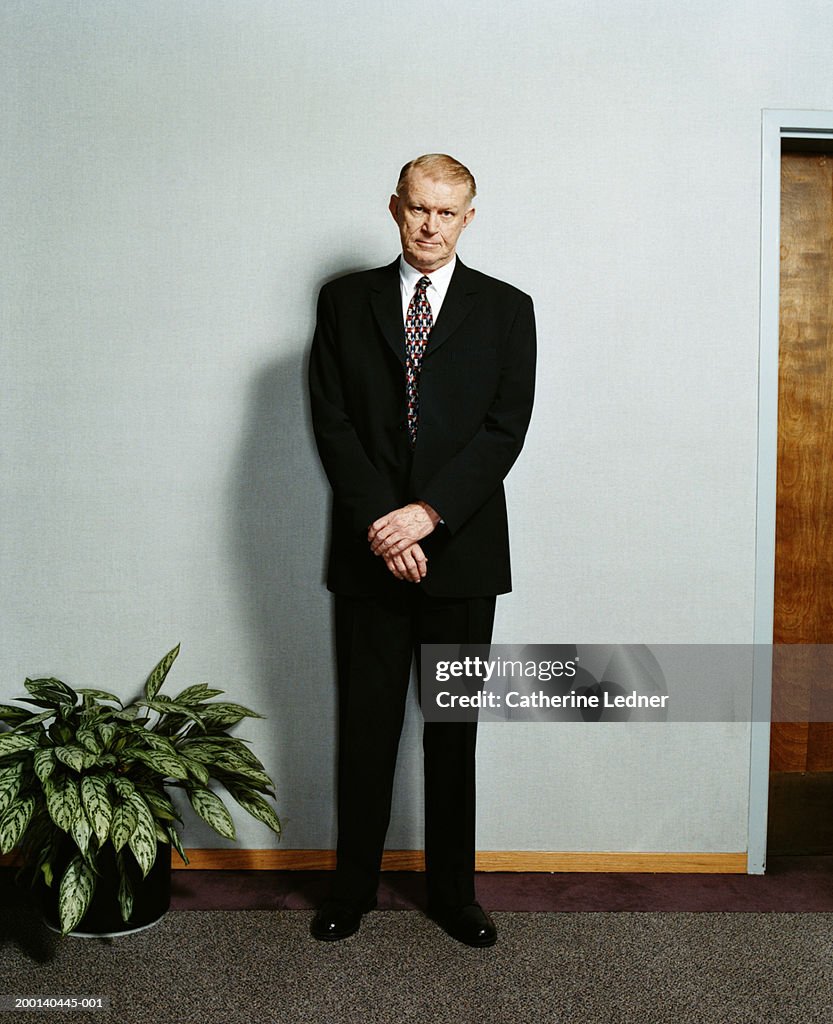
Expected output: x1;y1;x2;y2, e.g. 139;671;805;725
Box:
0;644;281;934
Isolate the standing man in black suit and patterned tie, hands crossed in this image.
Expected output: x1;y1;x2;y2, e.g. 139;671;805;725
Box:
309;154;535;946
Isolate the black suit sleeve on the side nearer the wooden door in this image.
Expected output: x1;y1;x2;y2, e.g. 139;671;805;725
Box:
419;295;536;534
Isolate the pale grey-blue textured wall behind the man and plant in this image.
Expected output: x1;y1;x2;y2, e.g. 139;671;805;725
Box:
6;0;833;851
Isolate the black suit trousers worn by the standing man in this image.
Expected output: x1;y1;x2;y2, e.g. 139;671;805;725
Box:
333;583;495;907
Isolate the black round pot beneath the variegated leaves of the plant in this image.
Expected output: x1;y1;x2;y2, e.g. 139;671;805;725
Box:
37;843;171;937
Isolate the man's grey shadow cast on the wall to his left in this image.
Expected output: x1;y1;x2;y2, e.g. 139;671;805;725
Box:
230;339;335;848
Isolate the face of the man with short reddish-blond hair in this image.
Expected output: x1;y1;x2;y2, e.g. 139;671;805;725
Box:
388;170;474;273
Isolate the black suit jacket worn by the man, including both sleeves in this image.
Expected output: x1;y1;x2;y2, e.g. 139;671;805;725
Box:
309;258;535;597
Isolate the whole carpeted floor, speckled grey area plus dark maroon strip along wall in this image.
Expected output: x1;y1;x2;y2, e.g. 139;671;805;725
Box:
0;858;833;1024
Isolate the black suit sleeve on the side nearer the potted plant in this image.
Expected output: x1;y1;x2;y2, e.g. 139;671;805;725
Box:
309;286;398;534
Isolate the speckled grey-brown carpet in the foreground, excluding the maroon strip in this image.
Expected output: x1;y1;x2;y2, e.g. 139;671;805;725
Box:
2;910;833;1024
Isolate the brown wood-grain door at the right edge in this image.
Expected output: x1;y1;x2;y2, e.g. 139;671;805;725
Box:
768;152;833;853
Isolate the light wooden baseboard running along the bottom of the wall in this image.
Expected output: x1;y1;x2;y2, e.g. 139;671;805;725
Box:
0;850;747;874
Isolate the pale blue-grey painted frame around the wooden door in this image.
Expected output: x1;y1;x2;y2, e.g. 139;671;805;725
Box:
747;110;833;874
